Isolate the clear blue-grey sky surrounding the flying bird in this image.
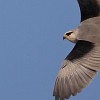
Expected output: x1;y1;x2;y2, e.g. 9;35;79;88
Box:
0;0;100;100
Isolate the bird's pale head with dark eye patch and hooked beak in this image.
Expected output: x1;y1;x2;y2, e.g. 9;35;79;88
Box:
63;30;78;43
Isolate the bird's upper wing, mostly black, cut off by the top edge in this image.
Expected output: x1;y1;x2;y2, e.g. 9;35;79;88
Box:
77;0;100;21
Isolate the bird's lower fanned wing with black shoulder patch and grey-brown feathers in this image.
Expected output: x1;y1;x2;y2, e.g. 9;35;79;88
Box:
53;40;100;100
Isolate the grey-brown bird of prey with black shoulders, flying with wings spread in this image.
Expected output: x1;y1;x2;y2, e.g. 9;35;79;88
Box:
53;0;100;100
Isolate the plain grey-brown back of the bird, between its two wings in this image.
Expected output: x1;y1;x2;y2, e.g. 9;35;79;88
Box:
77;16;100;44
